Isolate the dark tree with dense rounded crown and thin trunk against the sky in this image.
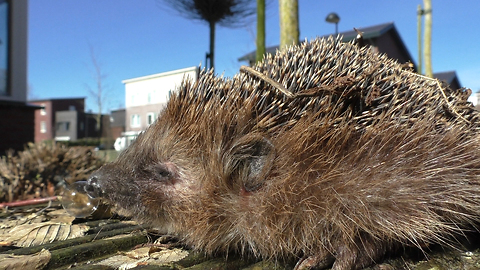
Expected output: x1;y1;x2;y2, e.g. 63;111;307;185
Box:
163;0;255;68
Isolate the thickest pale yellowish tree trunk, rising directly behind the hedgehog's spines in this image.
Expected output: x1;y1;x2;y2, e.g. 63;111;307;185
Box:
278;0;299;48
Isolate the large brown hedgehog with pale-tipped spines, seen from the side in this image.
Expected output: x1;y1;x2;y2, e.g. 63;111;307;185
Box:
85;38;480;270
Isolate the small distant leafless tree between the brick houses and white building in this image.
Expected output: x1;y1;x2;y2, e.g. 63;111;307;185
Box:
86;45;107;135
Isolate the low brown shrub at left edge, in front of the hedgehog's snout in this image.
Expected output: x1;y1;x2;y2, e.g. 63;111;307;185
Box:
0;143;105;202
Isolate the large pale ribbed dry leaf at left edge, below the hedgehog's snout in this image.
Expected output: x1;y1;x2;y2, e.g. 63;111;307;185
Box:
0;222;89;247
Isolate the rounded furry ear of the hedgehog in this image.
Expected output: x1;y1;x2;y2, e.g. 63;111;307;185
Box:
227;135;275;192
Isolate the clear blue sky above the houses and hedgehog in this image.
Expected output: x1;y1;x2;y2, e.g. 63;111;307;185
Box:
28;0;480;111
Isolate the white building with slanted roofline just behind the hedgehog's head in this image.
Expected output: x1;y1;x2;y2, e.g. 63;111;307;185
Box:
122;67;199;133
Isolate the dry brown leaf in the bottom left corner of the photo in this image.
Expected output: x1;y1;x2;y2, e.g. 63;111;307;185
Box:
0;249;51;270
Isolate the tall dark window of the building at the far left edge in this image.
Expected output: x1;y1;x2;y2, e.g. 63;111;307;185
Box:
0;1;9;96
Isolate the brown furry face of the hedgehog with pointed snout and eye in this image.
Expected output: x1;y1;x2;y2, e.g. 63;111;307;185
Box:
85;121;199;227
